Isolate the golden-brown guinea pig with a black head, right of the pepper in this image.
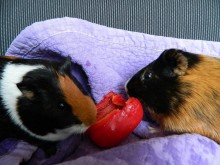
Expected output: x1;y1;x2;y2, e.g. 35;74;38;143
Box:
126;49;220;143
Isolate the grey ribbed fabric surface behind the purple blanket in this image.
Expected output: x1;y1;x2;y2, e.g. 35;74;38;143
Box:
0;0;220;55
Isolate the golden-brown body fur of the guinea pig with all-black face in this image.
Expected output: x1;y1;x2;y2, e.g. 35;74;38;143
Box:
155;56;220;143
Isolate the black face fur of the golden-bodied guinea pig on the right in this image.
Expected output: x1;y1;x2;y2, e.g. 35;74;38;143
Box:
127;49;200;115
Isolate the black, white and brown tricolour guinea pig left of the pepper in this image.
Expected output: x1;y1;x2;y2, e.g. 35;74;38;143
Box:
0;56;96;155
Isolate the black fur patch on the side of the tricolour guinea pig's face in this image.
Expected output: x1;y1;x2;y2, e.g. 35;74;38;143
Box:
18;69;81;135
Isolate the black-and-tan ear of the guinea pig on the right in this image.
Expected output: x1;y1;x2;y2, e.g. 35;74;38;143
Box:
161;49;188;77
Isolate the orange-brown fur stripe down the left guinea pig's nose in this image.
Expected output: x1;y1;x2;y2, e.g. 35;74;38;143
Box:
58;74;96;126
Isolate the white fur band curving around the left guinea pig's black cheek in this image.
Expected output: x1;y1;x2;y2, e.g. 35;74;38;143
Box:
0;63;88;141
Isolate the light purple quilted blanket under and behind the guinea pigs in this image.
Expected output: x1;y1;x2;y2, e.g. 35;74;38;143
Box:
0;18;220;165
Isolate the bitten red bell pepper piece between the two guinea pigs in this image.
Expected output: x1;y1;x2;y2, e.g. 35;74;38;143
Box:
88;92;143;148
